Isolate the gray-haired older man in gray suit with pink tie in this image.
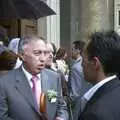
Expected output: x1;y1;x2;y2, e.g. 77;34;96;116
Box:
0;36;68;120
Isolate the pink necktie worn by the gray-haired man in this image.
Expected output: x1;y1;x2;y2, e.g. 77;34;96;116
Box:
31;76;41;106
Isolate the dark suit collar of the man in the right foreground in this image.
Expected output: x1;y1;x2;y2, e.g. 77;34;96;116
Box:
83;77;120;112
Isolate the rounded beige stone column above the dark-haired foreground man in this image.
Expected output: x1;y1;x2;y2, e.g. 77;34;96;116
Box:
79;0;114;41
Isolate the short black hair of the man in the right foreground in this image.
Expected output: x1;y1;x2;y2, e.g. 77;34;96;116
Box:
86;31;120;75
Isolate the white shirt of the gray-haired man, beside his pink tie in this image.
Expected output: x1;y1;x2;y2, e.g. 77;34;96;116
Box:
22;66;41;106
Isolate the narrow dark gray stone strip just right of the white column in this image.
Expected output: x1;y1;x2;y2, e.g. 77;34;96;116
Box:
60;0;71;47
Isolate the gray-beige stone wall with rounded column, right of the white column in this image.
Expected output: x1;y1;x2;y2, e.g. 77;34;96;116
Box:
60;0;114;47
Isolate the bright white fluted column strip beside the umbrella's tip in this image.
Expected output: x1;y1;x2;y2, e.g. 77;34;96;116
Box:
47;0;60;48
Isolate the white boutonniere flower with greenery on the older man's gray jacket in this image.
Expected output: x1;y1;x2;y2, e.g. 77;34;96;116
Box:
47;89;57;103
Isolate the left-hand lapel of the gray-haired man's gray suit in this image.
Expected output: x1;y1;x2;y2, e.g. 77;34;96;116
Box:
15;68;39;112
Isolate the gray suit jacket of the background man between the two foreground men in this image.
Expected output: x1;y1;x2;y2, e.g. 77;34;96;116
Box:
68;58;89;101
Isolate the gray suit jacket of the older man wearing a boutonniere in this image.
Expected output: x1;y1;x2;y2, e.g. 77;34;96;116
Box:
0;68;68;120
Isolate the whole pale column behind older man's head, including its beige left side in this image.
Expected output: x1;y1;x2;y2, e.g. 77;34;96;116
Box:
37;0;60;48
